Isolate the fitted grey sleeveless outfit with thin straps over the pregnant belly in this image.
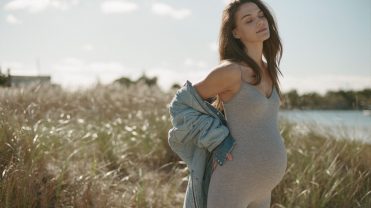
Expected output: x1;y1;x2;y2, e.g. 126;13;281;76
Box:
207;71;287;208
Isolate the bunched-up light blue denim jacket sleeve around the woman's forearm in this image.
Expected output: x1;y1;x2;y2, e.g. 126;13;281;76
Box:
170;106;229;152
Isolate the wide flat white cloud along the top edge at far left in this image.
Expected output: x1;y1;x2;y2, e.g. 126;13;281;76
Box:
4;0;79;13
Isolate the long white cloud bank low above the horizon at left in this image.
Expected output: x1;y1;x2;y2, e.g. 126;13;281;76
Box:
0;57;137;90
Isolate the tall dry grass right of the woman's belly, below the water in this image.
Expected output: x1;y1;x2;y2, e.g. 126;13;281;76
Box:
272;120;371;208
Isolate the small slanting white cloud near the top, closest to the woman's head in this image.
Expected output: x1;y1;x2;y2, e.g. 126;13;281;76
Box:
152;3;191;20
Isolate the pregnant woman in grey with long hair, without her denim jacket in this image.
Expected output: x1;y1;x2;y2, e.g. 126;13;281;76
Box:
194;0;287;208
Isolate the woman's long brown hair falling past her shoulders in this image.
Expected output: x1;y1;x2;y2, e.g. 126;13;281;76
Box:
212;0;282;113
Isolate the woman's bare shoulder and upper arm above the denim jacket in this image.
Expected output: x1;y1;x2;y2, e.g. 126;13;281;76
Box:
194;61;241;99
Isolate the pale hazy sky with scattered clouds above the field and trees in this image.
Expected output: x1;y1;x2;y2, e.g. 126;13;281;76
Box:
0;0;371;94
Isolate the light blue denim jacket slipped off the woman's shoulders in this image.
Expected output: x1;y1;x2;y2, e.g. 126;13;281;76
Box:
168;80;235;208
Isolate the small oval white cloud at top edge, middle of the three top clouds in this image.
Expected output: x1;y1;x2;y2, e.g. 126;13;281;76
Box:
101;0;139;14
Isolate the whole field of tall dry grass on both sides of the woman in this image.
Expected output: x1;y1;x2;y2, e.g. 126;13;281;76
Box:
0;84;371;208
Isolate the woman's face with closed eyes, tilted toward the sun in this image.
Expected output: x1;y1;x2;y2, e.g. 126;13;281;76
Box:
232;2;270;44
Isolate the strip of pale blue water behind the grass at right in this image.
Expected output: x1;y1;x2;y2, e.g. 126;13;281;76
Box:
279;110;371;143
